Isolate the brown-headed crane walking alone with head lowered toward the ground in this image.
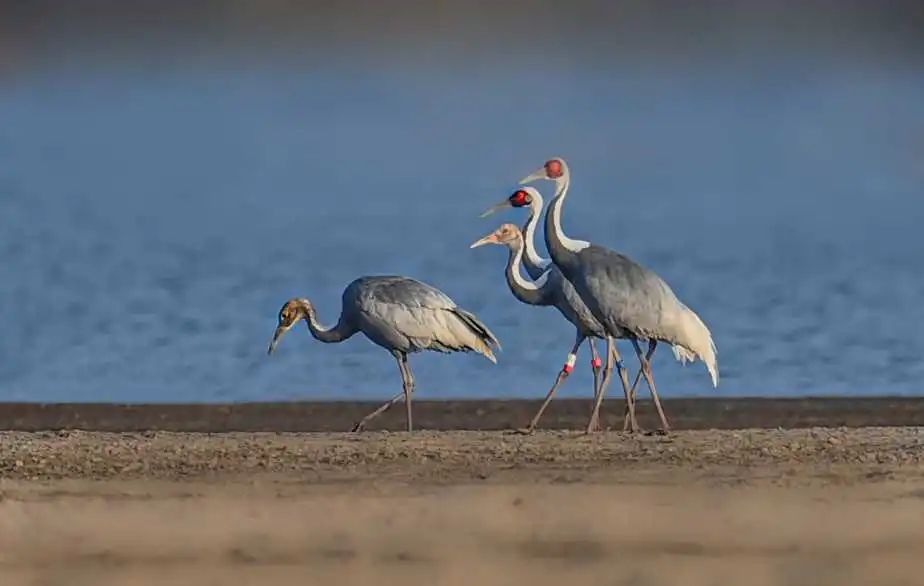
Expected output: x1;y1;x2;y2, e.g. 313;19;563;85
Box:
268;276;500;431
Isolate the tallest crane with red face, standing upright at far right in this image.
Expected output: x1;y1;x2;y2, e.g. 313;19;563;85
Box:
520;158;719;432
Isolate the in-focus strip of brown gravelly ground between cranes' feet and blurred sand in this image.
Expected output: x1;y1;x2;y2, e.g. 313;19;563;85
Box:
0;427;924;482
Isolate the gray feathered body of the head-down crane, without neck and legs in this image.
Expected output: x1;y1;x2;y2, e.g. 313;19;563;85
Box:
340;276;500;362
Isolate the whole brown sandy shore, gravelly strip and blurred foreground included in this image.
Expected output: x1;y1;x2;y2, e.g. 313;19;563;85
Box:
0;428;924;586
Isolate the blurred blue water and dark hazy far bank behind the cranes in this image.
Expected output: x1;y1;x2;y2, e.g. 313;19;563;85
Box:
0;0;924;401
